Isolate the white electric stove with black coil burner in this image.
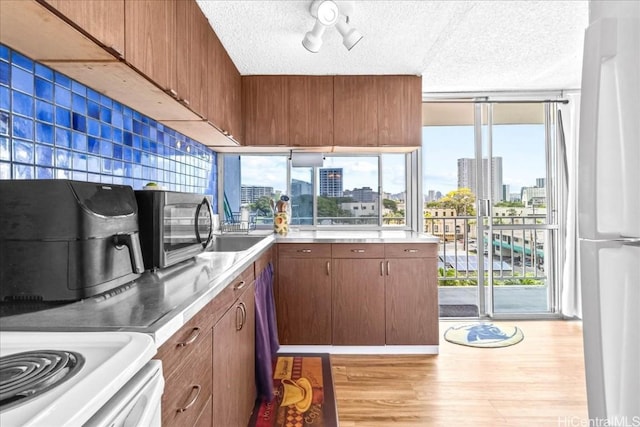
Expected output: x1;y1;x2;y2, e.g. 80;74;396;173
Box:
0;331;164;427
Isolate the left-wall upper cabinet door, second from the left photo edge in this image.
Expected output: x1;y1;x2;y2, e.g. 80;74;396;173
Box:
124;0;177;95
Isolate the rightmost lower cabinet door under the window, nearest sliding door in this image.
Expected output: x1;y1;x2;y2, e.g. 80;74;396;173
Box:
385;258;438;345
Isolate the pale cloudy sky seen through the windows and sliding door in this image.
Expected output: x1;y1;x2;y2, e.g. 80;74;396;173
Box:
242;125;545;195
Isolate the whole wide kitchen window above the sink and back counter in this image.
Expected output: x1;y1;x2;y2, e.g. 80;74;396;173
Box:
220;153;410;228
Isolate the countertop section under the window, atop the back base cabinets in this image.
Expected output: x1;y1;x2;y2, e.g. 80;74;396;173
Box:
276;229;439;243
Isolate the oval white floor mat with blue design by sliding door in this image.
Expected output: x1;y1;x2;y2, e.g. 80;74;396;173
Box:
444;323;524;348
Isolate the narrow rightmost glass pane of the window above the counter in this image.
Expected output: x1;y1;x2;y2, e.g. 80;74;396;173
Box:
382;154;407;226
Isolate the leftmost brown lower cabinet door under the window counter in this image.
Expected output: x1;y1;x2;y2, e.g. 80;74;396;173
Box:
276;258;331;345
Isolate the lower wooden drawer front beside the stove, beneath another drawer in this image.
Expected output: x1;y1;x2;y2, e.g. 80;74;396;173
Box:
162;330;213;426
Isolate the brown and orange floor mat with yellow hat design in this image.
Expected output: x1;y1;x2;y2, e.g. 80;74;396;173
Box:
249;353;338;427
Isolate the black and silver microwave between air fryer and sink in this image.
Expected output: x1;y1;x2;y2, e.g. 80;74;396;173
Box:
135;190;213;270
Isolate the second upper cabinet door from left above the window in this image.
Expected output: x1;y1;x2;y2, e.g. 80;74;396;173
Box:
287;76;333;147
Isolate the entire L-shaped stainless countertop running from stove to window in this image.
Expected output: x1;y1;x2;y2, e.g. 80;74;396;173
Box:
0;230;438;347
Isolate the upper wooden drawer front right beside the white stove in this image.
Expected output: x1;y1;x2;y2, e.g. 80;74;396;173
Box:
155;310;213;378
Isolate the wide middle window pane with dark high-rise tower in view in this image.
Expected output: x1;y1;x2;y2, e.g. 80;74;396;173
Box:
317;156;380;226
